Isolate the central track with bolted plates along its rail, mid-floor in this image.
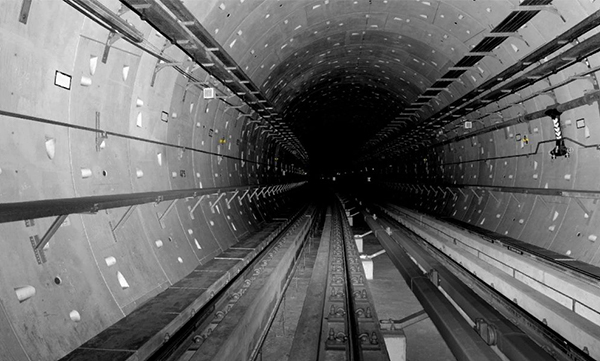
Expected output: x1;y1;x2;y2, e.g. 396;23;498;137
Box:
289;199;389;361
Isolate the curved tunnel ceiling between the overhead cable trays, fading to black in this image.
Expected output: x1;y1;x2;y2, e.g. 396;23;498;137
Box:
192;1;516;172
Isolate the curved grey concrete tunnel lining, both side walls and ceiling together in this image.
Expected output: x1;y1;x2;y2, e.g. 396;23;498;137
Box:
0;0;600;360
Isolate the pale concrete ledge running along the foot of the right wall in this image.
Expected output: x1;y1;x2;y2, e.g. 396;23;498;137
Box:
382;207;600;358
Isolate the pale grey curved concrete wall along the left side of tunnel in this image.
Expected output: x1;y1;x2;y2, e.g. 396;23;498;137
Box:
0;1;298;360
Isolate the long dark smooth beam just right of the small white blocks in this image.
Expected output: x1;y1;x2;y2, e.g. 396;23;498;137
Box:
364;213;501;361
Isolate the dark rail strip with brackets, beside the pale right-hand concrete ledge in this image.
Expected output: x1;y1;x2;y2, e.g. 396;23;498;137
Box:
378;211;565;361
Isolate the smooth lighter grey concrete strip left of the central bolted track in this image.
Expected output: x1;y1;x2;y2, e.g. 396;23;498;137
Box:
190;205;313;361
